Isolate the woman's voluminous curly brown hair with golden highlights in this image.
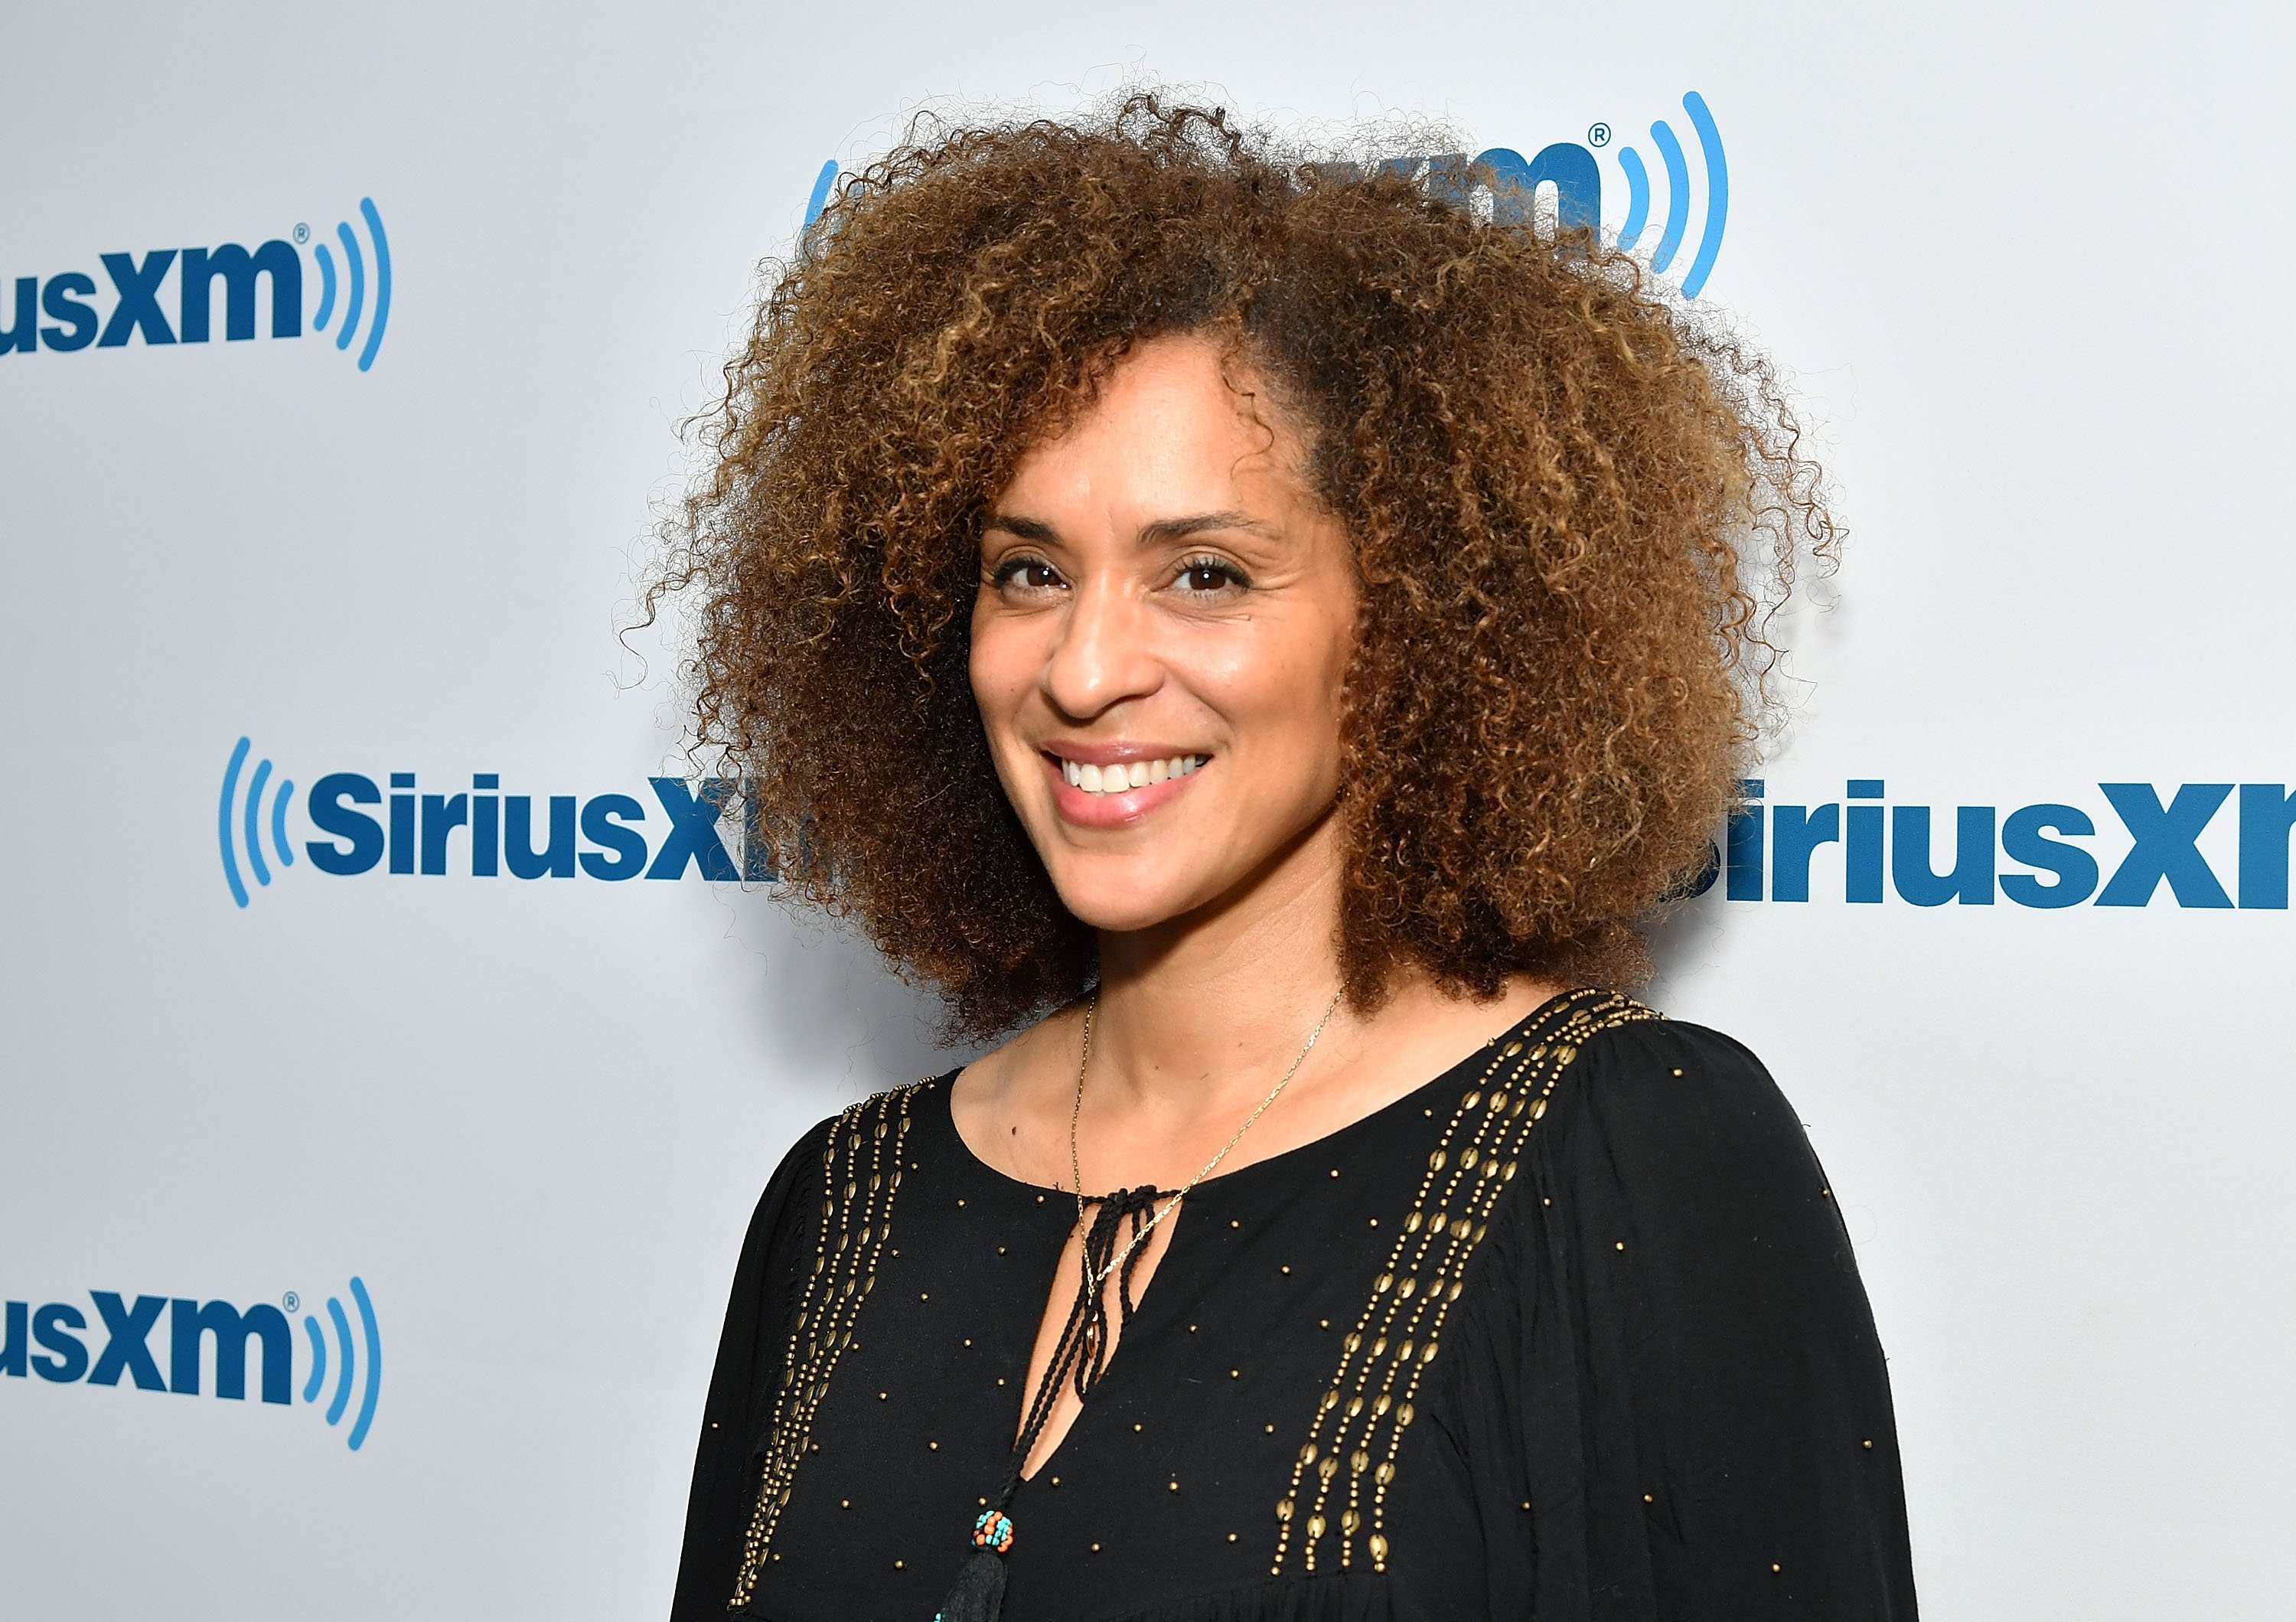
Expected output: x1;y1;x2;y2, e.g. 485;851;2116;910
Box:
647;94;1837;1036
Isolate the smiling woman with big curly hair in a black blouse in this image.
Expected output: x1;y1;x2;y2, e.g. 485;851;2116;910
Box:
666;96;1913;1622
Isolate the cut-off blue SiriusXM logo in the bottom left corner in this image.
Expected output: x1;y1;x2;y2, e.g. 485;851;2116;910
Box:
0;1278;383;1452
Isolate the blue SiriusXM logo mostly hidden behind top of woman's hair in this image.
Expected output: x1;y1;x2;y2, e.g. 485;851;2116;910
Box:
806;90;1729;299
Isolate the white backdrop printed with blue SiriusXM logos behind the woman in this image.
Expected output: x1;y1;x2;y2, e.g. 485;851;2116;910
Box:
0;0;2296;1622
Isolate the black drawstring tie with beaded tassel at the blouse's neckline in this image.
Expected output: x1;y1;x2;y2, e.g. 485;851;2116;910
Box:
932;1183;1178;1622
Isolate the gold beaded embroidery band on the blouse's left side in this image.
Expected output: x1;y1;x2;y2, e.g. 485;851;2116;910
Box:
732;1082;925;1608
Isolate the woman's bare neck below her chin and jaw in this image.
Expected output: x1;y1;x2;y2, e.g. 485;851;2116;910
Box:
1093;818;1345;1110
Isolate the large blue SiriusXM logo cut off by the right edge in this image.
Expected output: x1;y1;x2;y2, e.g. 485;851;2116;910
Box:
1694;776;2296;912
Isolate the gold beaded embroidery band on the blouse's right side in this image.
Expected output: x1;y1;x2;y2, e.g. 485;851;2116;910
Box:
1270;990;1662;1576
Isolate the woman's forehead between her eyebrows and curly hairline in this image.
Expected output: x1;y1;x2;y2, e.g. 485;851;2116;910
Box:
999;335;1306;517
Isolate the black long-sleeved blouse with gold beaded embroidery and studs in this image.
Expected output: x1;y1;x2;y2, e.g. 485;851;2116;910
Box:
673;990;1915;1622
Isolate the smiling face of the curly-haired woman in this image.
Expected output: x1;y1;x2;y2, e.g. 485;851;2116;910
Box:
971;338;1355;931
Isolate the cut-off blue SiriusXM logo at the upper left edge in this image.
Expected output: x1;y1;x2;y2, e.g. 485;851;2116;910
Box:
0;197;390;372
